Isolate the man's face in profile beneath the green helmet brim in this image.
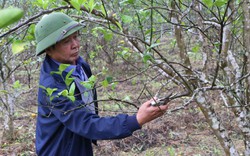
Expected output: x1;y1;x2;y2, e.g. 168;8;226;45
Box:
47;32;80;65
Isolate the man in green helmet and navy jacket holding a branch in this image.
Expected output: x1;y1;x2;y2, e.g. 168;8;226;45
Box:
35;12;167;156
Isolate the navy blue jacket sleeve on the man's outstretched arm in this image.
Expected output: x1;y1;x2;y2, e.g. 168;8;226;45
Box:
40;82;141;140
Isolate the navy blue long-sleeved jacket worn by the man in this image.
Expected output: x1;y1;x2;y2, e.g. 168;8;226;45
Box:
36;56;140;156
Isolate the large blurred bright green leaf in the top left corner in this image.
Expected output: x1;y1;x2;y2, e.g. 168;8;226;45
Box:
0;8;24;29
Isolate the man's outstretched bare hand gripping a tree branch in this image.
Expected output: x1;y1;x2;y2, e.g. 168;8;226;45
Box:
136;99;168;126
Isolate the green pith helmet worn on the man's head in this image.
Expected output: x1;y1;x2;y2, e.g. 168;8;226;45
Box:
35;12;84;56
